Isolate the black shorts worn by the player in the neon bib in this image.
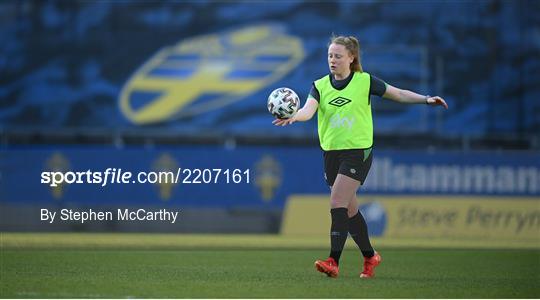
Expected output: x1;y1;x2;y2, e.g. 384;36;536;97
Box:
324;148;373;186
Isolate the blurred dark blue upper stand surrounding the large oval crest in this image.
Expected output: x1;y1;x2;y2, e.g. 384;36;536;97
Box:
0;1;540;149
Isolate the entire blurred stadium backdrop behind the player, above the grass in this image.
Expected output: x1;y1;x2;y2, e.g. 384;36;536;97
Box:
0;0;540;297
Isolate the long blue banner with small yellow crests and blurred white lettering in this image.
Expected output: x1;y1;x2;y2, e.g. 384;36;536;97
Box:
0;146;540;209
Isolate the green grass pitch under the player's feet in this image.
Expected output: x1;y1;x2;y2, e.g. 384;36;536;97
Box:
0;234;540;298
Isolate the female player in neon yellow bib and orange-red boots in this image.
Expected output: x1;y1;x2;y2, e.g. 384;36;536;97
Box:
272;36;448;278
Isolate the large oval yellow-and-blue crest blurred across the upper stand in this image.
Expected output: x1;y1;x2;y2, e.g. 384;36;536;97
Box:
119;24;304;124
